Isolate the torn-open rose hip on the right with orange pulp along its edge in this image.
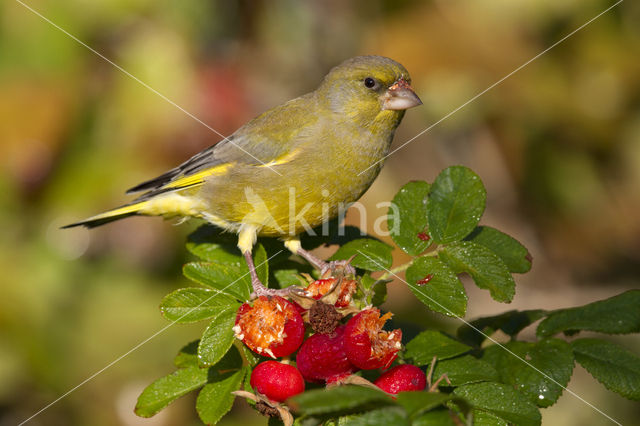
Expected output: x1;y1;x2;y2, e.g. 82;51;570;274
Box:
344;308;402;370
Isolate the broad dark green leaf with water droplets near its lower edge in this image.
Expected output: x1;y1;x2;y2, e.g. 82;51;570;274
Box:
495;339;574;407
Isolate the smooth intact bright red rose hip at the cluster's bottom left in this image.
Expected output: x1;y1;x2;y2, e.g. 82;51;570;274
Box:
250;361;304;402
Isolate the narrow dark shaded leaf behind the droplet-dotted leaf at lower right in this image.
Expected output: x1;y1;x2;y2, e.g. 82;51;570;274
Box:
457;309;547;346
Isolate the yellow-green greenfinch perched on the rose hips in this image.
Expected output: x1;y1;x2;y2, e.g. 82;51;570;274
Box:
63;55;422;297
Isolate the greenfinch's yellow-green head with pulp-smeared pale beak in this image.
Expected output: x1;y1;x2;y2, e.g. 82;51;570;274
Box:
317;56;422;128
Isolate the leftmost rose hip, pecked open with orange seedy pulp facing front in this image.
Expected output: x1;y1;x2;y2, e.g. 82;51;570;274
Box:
233;296;304;358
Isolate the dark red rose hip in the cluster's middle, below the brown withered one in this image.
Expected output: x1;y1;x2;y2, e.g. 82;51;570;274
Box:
296;325;357;383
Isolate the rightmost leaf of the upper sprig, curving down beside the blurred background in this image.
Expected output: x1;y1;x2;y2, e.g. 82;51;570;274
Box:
465;226;531;274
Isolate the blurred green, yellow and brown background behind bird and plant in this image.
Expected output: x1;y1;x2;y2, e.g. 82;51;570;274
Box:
0;0;640;425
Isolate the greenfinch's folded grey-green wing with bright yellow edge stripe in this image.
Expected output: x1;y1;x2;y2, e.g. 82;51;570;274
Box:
127;96;317;200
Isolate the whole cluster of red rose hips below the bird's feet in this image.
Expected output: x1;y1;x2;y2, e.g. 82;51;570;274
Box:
234;278;426;414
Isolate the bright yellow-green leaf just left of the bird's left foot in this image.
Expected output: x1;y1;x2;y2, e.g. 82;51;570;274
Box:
182;262;252;301
